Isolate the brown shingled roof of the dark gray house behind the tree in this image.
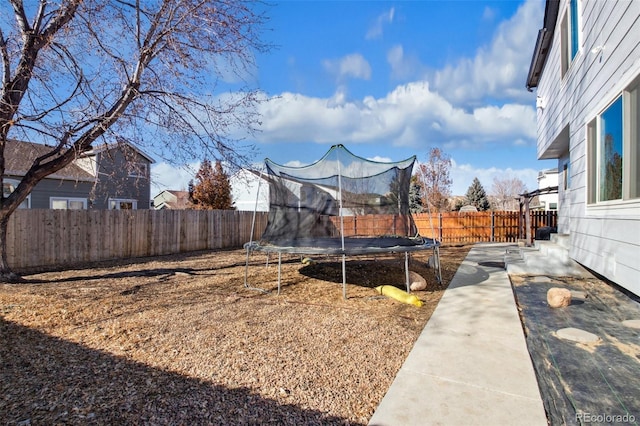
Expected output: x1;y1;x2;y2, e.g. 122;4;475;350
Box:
4;139;95;181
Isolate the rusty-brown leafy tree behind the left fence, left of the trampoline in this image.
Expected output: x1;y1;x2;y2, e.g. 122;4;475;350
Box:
190;158;235;210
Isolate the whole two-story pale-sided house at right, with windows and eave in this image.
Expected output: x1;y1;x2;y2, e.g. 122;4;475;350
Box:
526;0;640;295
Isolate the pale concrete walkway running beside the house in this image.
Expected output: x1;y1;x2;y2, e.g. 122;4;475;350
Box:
369;244;547;426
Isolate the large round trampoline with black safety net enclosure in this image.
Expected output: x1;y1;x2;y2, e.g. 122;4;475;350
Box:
244;145;442;299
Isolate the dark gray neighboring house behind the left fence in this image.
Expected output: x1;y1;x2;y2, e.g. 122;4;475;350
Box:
4;140;153;209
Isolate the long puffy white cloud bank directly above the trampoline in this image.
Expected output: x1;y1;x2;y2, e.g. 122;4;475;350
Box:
256;82;536;147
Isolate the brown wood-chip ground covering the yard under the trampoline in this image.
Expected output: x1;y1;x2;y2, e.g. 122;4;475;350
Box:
0;246;471;425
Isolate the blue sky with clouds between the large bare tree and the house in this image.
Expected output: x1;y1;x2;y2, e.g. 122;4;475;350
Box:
152;0;555;201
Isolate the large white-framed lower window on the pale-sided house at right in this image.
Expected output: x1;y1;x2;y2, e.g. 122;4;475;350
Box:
587;77;640;204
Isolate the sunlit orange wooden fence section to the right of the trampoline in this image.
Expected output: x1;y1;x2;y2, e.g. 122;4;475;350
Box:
413;211;558;243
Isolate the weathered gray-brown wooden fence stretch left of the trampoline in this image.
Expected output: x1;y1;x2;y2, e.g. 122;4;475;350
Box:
7;209;267;271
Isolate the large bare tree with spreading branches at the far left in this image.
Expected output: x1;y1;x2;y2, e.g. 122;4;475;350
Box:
0;0;269;280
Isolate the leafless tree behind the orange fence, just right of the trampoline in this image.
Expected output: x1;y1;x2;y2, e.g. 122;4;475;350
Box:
417;148;453;211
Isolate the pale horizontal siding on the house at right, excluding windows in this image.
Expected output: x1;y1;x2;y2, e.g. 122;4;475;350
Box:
537;0;640;294
